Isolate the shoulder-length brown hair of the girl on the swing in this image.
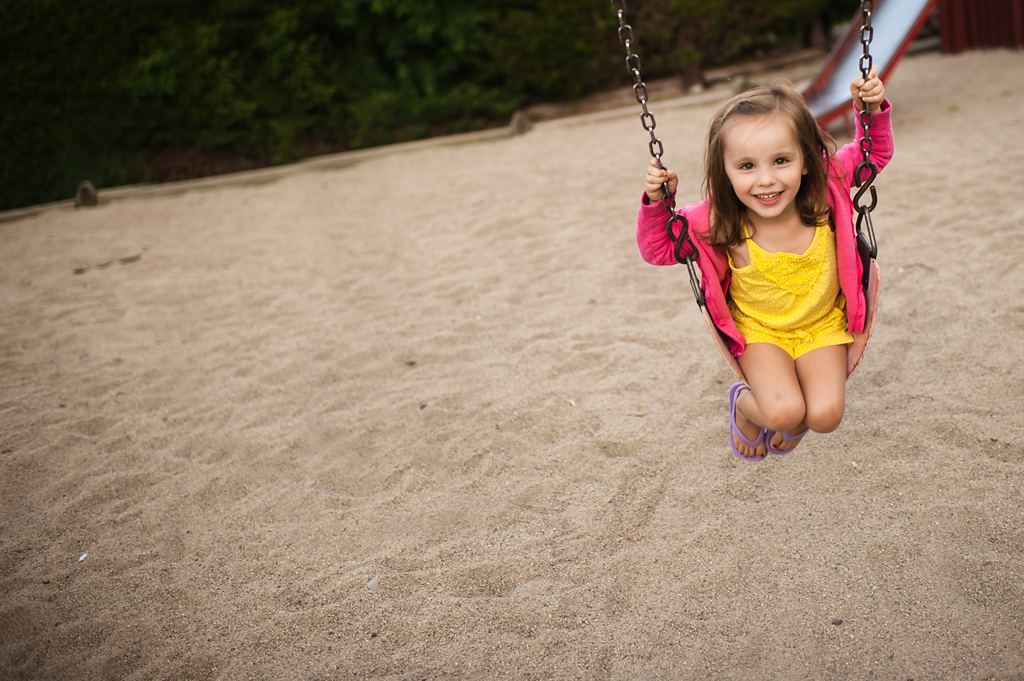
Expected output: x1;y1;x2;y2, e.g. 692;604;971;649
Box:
703;80;836;247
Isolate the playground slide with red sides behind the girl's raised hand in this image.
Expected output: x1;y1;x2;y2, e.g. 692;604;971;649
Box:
804;0;938;127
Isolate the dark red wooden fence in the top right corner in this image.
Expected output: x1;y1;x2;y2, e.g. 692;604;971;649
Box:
939;0;1024;52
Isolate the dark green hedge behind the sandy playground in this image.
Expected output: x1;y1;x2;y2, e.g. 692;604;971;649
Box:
0;0;859;210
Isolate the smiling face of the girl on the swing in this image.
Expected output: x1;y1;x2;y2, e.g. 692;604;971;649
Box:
723;116;807;227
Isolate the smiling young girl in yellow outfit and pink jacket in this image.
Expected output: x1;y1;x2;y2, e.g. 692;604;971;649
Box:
637;69;893;461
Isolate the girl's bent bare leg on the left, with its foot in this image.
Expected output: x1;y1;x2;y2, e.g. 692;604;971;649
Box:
733;343;810;457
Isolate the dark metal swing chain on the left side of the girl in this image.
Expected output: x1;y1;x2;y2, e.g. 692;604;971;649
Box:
611;0;705;307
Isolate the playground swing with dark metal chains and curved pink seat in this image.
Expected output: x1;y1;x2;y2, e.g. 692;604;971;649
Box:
611;0;879;383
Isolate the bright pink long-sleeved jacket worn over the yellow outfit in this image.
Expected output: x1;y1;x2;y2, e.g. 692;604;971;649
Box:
637;99;893;357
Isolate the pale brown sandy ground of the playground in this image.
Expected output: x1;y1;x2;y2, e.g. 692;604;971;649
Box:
6;51;1024;681
